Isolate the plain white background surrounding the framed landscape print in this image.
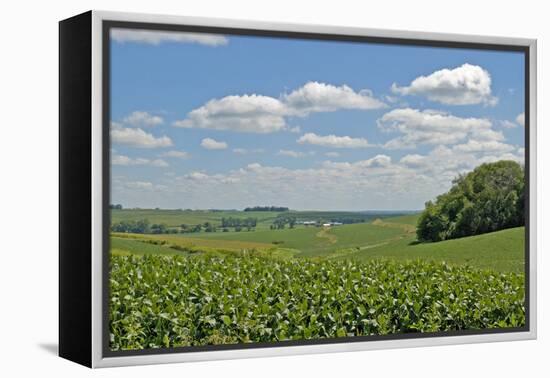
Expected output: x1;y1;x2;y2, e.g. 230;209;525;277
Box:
0;0;550;378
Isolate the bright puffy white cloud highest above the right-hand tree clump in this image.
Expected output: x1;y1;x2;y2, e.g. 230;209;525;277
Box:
391;63;498;106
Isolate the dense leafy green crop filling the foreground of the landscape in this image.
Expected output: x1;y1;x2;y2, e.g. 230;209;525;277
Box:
109;255;525;350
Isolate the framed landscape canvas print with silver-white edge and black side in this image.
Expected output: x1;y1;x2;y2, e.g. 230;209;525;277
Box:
59;11;536;367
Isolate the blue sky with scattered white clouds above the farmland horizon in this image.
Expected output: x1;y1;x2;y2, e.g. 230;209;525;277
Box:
111;29;524;210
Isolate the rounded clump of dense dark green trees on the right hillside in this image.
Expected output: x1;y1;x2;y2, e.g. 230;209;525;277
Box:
416;160;525;242
